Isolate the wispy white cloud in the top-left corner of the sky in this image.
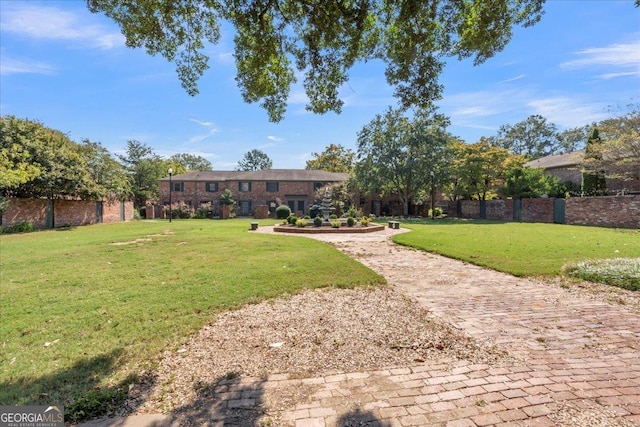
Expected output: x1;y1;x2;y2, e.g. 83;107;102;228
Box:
1;4;125;49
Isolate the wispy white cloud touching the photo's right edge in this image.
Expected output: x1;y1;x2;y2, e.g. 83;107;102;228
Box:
560;40;640;79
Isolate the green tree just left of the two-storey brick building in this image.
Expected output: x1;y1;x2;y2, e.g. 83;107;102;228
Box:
118;140;169;209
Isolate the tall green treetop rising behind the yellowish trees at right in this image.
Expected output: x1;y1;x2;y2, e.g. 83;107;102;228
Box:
495;115;562;160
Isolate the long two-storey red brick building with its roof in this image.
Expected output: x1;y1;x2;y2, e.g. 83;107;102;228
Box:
158;169;349;216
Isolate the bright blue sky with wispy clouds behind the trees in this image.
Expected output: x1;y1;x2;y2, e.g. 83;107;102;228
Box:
0;0;640;170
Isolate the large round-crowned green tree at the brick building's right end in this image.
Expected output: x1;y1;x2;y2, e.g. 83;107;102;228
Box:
354;108;454;216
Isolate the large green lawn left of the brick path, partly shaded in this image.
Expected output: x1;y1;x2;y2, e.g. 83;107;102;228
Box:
0;220;384;415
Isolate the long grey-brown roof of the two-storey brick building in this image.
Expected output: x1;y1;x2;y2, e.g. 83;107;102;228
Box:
160;169;349;182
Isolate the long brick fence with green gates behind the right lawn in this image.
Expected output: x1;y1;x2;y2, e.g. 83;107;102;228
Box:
447;195;640;228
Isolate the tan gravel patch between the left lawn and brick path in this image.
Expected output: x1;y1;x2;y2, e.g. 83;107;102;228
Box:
128;287;513;413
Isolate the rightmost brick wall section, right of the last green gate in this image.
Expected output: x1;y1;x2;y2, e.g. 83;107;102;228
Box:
565;195;640;228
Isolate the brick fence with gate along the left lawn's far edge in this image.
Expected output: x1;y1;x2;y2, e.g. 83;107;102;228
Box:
0;199;133;229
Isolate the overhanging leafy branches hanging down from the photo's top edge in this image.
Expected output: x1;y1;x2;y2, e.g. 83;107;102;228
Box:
87;0;544;122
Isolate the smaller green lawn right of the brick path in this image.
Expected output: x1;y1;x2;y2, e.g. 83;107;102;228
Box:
394;220;640;276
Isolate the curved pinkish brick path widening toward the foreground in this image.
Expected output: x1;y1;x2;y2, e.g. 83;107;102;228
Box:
81;229;640;427
